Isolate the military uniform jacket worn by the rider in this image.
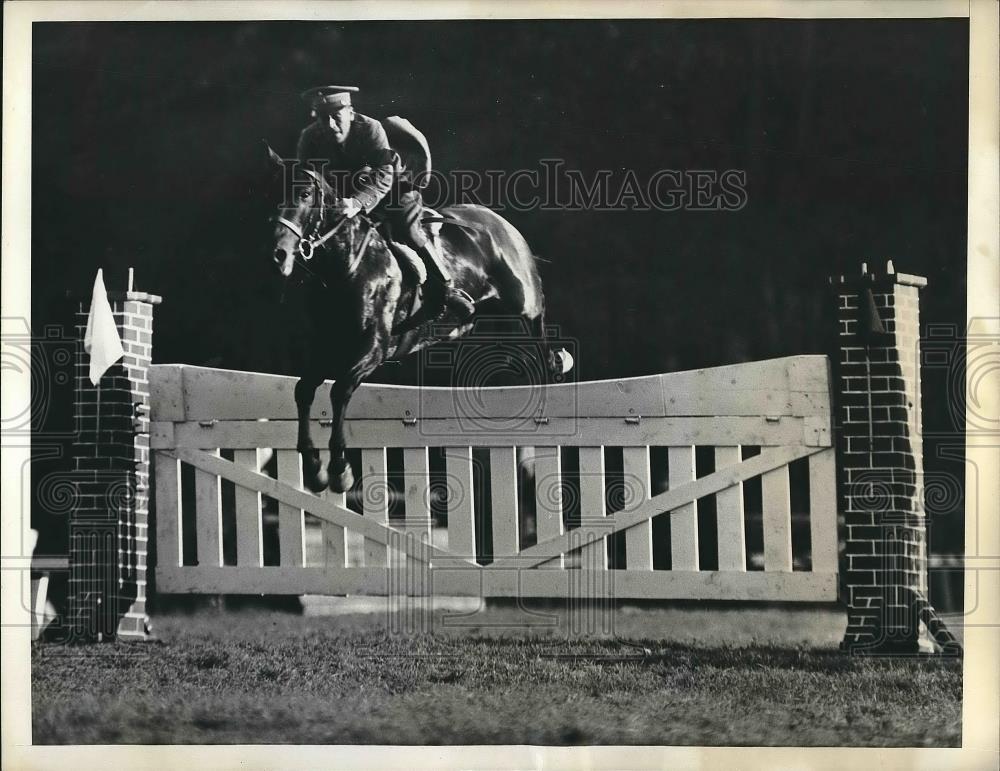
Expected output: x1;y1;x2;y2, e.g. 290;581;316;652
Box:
296;113;396;213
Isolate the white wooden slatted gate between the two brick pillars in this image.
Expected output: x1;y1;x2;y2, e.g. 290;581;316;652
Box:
150;356;837;601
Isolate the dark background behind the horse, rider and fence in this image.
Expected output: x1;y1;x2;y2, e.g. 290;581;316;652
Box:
31;19;968;560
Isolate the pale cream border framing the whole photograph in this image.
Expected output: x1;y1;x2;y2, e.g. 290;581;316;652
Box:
0;0;1000;769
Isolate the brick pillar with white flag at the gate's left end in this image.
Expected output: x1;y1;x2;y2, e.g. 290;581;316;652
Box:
69;292;160;641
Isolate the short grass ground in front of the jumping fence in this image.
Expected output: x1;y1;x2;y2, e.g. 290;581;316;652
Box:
32;611;962;747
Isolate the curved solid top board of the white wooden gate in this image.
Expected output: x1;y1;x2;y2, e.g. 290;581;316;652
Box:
170;356;830;422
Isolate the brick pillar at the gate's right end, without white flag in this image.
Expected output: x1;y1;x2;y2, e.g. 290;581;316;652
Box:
832;262;929;653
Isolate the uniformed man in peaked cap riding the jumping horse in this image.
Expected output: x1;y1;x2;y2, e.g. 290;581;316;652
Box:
297;86;475;321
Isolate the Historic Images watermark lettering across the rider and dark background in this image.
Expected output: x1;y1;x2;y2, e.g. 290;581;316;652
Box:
283;158;748;213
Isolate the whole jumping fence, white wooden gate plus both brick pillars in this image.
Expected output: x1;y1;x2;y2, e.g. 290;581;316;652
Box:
56;263;953;652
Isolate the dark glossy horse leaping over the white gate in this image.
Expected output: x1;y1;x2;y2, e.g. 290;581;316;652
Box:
268;148;573;494
